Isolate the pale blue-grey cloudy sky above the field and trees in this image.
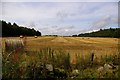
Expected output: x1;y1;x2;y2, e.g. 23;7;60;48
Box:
0;0;118;35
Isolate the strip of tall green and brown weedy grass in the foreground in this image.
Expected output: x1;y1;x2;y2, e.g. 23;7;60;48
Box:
2;48;119;80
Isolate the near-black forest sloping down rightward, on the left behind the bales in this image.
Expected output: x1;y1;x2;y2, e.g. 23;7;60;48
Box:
0;20;41;37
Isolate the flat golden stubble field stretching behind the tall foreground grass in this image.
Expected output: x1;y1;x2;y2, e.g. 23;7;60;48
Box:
2;36;118;56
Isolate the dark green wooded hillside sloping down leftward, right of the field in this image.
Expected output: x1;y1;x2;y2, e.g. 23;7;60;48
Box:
77;28;120;38
